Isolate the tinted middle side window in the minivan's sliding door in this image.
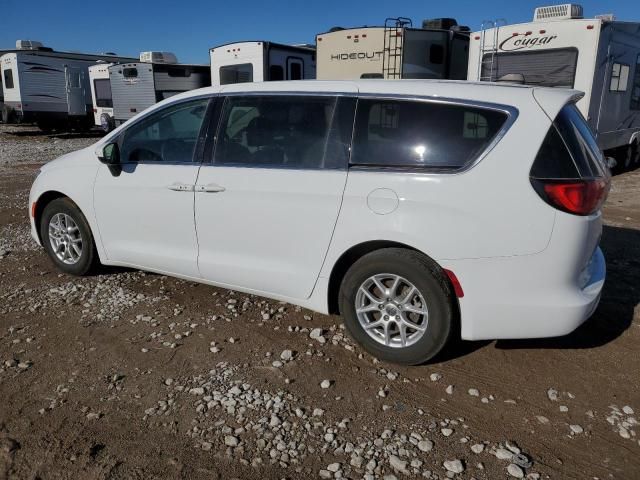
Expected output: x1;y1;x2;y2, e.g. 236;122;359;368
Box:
214;96;338;169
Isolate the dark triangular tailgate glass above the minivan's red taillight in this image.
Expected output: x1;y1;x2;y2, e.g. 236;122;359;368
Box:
531;104;606;179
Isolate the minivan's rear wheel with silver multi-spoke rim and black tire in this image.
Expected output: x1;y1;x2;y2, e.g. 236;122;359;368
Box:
339;248;457;365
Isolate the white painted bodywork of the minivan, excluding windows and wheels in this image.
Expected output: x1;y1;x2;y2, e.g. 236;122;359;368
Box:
30;80;605;339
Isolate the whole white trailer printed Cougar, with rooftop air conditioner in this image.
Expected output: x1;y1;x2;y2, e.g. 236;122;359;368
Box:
468;4;640;168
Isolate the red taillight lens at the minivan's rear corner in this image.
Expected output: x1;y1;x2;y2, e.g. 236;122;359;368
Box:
535;179;609;215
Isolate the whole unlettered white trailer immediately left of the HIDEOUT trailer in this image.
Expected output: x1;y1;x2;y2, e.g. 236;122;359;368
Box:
209;42;316;85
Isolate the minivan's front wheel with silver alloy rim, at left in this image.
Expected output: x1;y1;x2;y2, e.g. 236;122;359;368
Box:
40;198;98;276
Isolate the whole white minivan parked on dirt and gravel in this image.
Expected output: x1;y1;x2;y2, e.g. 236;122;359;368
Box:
29;80;610;364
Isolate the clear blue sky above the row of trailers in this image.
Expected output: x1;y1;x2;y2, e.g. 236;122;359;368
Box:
0;0;640;63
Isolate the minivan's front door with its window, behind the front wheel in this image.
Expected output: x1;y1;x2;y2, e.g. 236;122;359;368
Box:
94;99;209;278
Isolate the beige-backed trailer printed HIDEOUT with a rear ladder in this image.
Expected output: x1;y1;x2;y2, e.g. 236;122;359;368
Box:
316;17;469;80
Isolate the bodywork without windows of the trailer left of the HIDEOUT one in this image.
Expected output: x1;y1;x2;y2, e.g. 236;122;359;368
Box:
209;42;316;86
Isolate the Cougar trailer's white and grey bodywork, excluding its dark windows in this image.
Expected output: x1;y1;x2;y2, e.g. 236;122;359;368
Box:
467;19;640;150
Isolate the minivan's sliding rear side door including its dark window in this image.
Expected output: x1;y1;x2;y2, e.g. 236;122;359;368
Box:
195;94;355;299
